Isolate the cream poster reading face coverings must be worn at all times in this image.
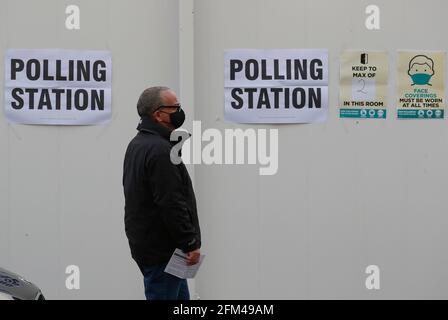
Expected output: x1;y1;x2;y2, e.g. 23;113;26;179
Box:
397;51;445;119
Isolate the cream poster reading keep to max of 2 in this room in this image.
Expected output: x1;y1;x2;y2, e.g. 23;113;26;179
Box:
339;51;389;119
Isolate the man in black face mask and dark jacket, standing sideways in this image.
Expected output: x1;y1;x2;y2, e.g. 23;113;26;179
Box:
123;87;201;300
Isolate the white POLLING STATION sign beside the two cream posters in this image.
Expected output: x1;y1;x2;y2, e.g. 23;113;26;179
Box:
224;49;328;123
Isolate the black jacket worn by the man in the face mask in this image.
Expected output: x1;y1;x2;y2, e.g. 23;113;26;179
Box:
123;117;201;268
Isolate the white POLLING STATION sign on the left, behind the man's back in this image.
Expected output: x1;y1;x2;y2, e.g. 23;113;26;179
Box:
4;49;112;125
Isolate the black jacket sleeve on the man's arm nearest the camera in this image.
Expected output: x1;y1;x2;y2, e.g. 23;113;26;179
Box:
146;147;200;252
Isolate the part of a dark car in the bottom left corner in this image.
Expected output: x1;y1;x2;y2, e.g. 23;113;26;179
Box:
0;268;41;300
